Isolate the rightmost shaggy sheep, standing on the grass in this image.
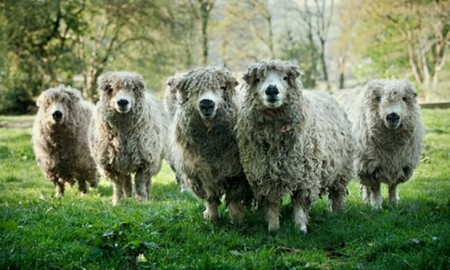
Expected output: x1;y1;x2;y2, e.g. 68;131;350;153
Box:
334;80;424;209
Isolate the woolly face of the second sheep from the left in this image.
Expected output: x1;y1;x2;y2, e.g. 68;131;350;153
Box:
99;72;145;114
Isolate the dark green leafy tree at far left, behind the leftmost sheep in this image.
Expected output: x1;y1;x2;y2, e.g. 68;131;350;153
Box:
0;1;84;113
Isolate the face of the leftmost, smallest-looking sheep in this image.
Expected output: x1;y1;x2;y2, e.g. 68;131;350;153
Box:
37;86;81;125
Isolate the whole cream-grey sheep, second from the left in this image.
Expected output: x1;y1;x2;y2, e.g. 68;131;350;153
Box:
89;71;168;206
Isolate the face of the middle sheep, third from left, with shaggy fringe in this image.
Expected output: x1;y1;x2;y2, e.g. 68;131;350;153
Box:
176;68;237;120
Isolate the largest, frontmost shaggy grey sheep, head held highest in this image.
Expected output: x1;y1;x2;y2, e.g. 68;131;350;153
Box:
237;60;354;233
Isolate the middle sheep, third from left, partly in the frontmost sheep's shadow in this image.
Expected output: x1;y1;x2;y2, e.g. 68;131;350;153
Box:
166;67;252;224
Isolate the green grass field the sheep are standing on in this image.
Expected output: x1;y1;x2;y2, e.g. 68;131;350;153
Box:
0;110;450;269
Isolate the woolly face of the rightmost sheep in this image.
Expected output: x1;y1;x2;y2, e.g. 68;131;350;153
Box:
367;80;417;129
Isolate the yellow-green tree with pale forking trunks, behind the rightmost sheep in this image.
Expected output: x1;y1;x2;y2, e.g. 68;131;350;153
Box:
355;0;450;100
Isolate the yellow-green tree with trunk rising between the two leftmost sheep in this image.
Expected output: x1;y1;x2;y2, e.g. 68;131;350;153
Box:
76;0;163;99
